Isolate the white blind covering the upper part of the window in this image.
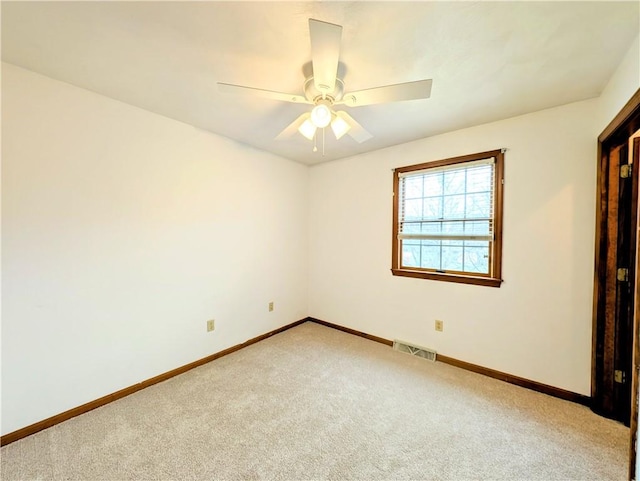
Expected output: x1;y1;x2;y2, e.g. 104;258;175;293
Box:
398;157;495;241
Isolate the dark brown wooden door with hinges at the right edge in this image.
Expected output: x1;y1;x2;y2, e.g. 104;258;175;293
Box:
592;137;638;426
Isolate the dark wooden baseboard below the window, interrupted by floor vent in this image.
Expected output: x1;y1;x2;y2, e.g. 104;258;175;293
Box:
308;317;591;406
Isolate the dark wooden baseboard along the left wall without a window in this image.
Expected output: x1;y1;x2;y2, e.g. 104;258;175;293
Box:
0;317;310;446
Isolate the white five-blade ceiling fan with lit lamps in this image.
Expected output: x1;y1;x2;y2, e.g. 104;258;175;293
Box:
218;18;432;151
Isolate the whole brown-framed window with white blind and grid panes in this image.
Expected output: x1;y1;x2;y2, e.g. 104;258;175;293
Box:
391;150;504;287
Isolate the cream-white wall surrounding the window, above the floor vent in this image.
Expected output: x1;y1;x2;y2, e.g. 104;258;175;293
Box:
309;100;597;394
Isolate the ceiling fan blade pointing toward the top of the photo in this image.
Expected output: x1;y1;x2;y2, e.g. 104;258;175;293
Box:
309;18;342;93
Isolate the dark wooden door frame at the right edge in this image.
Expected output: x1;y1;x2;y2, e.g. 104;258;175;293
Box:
591;89;640;479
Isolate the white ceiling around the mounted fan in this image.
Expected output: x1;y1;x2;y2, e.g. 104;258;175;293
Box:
2;1;640;164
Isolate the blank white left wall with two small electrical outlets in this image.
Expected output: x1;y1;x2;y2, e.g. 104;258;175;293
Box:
2;64;308;434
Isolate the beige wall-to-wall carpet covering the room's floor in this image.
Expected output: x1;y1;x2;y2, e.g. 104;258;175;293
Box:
1;323;629;480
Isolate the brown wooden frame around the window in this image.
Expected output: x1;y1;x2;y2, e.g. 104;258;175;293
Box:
391;149;504;287
